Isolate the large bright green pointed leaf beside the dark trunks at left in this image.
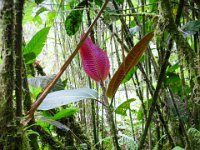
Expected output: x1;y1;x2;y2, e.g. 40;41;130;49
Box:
23;27;50;64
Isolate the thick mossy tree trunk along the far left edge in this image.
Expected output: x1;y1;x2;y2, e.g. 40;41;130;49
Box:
0;0;15;149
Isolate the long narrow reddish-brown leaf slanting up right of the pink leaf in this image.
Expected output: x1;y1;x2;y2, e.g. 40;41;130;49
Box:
106;32;154;97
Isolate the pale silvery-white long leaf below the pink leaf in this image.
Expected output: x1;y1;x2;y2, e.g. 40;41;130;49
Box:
38;88;97;110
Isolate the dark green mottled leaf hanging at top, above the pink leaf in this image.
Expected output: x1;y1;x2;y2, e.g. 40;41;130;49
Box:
65;1;85;36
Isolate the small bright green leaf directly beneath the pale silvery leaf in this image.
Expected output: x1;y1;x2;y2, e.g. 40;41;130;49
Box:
52;108;79;120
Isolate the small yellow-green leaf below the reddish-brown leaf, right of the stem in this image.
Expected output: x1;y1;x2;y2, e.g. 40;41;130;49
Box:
115;98;135;116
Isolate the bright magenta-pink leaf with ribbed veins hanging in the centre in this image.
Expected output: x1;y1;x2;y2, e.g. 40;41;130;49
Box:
80;33;110;82
